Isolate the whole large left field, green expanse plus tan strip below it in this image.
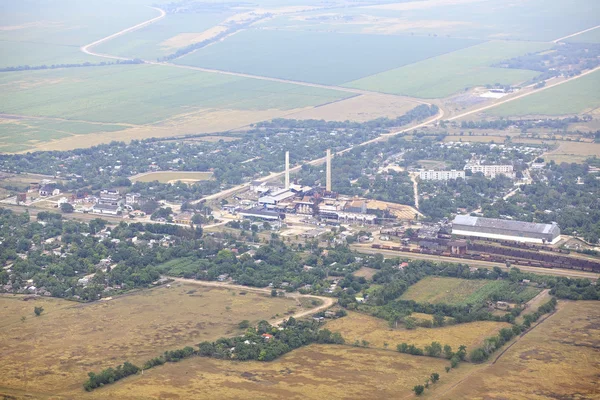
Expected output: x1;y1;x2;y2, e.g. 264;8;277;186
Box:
0;65;351;151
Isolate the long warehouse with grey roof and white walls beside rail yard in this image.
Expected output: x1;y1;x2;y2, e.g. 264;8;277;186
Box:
452;215;560;244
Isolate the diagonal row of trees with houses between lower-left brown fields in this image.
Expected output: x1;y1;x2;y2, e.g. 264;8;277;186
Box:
83;317;345;391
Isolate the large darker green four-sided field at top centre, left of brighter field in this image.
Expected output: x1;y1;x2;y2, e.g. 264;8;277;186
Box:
177;30;479;84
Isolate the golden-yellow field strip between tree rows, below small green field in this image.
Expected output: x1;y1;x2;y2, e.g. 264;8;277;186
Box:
326;312;510;350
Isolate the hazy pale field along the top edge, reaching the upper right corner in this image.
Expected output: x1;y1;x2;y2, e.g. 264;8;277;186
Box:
259;0;600;41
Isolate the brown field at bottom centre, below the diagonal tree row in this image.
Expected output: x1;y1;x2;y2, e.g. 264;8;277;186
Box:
77;345;479;400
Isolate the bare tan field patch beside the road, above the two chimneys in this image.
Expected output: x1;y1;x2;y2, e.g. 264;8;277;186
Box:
287;94;419;122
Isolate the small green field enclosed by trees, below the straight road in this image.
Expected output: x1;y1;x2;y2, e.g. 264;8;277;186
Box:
400;276;540;305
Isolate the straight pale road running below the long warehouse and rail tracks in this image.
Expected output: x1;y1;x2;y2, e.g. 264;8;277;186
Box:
352;245;600;280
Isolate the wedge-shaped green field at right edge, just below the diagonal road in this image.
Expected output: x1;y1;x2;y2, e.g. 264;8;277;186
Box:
489;71;600;116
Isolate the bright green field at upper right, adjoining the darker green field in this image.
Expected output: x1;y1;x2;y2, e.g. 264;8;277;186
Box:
344;41;550;98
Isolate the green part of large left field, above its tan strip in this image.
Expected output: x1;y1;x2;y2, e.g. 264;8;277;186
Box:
0;65;349;124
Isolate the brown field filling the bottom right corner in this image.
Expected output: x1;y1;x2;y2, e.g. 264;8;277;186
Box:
438;301;600;400
